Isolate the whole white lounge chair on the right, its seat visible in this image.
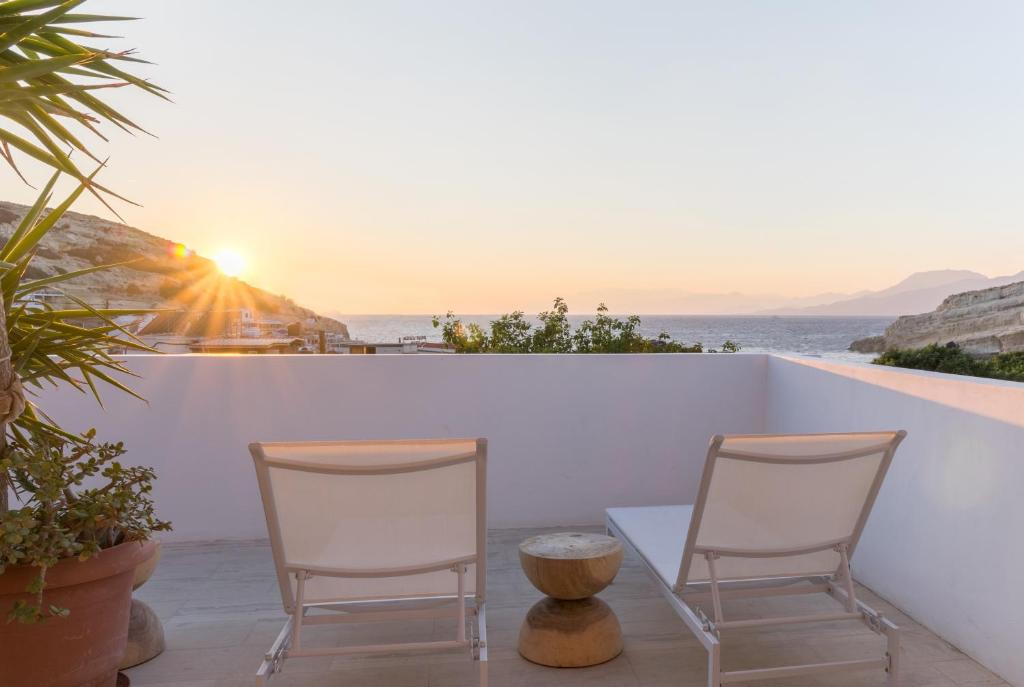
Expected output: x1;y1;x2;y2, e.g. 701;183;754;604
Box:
606;431;906;687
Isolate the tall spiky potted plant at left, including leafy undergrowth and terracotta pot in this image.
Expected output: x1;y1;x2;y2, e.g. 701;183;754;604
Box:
0;5;169;687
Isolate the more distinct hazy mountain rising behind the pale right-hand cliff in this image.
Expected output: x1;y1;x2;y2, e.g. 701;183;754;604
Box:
759;269;1024;317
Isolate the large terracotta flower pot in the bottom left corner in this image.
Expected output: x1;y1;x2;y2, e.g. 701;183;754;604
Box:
0;542;157;687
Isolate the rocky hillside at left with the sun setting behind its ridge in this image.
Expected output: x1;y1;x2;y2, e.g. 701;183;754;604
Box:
0;201;348;337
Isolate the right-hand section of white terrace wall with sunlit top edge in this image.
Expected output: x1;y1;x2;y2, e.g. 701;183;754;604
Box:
767;357;1024;685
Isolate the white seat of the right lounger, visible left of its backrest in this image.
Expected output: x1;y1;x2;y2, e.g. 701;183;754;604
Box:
605;506;693;588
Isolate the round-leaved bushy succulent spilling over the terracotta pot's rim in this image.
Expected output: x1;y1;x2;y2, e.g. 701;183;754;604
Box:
0;430;170;622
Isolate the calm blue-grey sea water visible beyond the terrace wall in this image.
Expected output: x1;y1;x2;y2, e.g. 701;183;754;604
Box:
339;315;892;360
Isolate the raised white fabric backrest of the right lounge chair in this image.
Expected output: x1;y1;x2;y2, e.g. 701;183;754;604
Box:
676;431;906;589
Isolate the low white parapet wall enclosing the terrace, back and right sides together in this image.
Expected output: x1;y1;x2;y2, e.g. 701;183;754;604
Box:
34;353;1024;685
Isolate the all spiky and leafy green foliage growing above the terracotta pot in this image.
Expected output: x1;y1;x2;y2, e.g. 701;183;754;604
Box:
0;0;169;622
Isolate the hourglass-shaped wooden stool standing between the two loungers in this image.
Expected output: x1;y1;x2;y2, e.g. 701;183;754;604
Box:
519;532;623;668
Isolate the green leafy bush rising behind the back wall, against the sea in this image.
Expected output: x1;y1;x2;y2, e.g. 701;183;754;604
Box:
433;298;739;353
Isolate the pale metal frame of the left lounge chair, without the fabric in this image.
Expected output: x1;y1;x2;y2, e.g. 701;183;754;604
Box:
249;438;487;687
